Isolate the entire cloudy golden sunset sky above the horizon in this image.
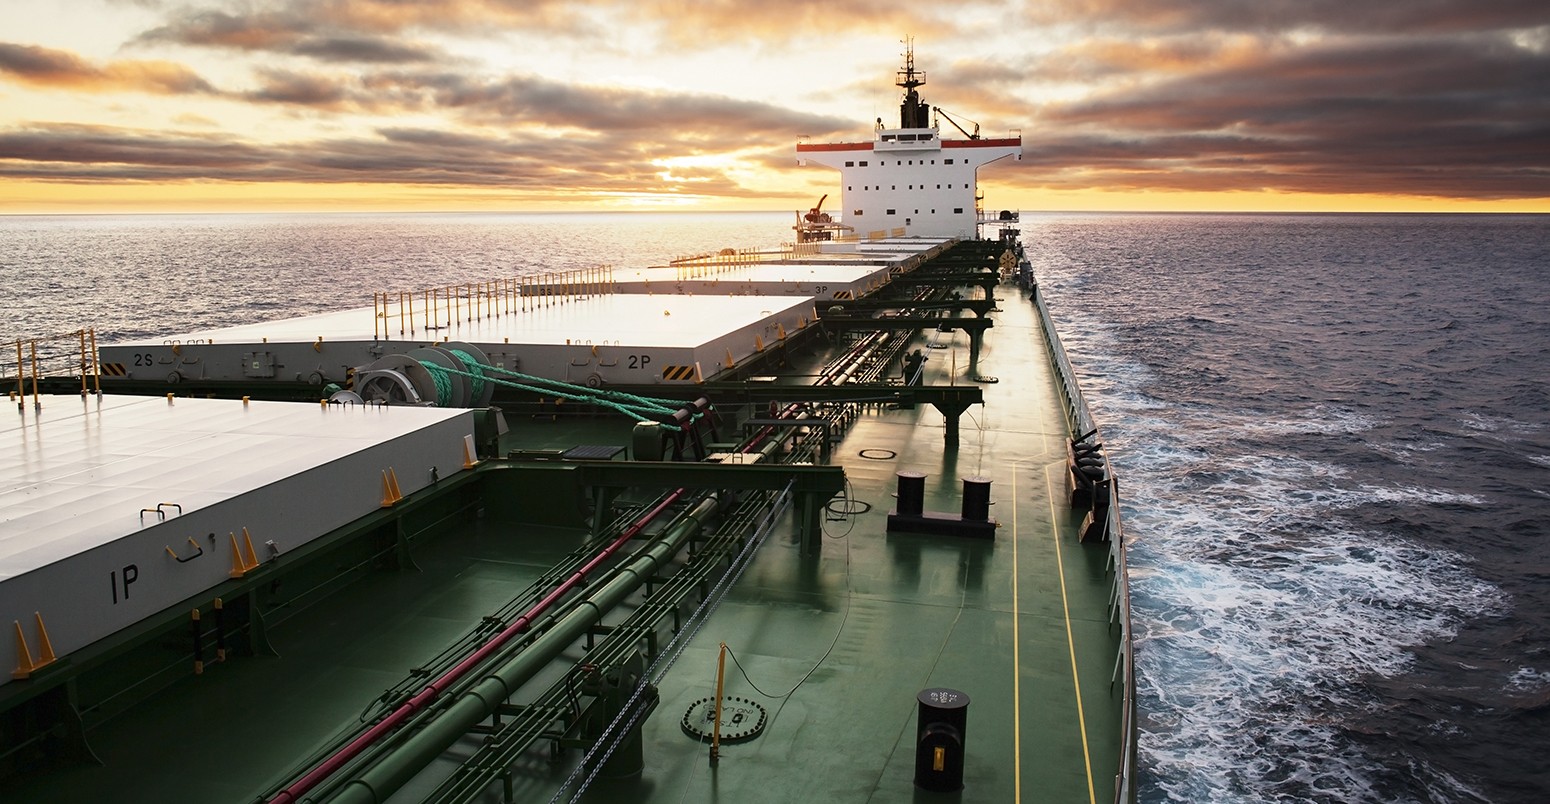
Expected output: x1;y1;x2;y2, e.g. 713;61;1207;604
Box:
0;0;1550;214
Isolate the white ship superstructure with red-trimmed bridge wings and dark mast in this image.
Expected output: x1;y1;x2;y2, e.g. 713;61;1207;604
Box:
797;43;1023;237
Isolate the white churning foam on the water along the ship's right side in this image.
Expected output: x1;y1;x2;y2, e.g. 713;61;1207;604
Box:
1062;306;1502;802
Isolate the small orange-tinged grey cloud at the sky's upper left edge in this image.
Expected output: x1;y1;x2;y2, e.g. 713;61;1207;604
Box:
0;42;215;94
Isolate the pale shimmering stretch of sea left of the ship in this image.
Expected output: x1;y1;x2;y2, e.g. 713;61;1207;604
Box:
0;212;792;342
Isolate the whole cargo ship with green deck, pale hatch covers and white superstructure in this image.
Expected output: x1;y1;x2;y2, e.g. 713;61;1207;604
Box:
0;50;1136;802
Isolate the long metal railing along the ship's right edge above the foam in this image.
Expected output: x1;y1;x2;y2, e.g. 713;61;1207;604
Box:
1032;283;1139;804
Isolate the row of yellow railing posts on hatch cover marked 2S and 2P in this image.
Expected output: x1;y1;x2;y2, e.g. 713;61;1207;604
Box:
372;265;615;339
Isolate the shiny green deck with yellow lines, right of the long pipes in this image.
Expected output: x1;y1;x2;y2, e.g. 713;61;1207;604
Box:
618;290;1122;802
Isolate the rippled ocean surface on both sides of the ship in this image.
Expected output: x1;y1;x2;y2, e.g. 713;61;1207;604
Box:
0;214;1550;804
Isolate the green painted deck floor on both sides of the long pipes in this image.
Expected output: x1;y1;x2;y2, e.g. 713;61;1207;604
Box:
6;281;1122;802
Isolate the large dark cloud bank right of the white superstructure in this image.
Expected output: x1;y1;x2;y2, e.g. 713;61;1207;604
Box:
1023;36;1550;198
